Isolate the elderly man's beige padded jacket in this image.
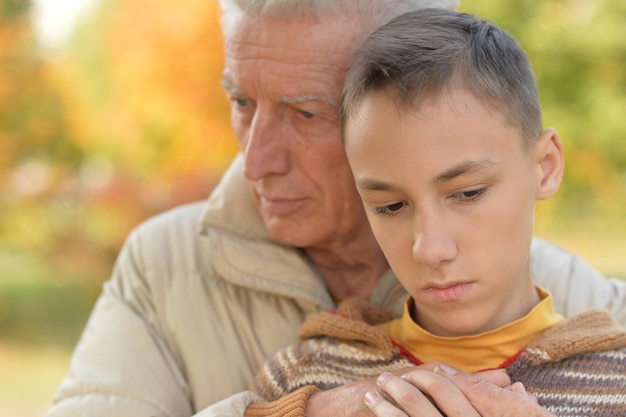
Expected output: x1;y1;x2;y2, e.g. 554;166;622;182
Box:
46;154;626;417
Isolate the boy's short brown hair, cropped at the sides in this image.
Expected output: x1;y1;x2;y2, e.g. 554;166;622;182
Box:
341;9;543;143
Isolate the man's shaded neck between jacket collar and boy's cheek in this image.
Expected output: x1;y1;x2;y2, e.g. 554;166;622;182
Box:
305;237;389;300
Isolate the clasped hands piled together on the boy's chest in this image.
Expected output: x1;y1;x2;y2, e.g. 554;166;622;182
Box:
306;362;553;417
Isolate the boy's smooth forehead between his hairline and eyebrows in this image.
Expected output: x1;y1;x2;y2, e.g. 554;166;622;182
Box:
344;89;526;159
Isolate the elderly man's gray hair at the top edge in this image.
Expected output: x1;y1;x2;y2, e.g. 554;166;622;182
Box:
219;0;458;30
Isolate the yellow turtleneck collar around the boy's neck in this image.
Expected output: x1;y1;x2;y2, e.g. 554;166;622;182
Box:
379;287;564;372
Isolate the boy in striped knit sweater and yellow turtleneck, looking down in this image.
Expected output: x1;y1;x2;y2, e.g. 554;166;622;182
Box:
241;9;626;416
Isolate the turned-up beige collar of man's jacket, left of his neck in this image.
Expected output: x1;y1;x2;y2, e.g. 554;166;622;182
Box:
200;154;334;308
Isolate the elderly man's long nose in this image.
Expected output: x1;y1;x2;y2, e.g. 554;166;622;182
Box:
243;108;292;181
